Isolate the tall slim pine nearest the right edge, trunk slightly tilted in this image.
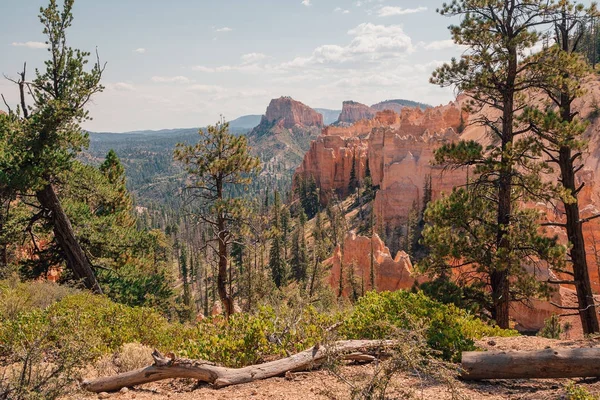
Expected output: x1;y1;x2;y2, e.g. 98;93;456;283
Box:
521;1;600;335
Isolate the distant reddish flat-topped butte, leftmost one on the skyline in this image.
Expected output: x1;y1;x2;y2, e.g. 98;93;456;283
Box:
263;97;323;129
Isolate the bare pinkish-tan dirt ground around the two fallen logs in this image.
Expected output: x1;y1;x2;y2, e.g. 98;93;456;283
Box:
64;336;600;400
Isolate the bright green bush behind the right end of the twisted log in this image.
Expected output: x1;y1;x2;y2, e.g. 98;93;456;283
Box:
340;291;516;361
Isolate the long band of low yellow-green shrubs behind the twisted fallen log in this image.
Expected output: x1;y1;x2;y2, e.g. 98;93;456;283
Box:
0;282;516;399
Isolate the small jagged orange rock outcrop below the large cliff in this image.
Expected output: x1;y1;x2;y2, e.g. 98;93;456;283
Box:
325;231;415;296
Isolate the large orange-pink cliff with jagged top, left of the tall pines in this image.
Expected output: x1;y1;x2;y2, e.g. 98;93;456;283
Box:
296;103;465;206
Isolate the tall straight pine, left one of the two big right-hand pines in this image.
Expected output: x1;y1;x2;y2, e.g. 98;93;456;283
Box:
431;0;560;328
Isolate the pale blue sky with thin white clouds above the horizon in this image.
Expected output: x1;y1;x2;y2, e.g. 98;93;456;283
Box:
0;0;468;132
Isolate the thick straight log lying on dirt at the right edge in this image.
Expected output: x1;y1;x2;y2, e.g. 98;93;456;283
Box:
461;347;600;380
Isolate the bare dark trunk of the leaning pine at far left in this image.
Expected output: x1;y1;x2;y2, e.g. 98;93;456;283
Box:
36;184;102;293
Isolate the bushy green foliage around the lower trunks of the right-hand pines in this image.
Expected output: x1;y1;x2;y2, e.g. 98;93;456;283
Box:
418;185;565;318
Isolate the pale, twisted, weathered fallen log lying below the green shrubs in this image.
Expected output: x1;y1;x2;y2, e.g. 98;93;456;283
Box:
82;340;395;393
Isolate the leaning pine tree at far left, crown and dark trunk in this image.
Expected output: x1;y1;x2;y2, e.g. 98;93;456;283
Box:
0;0;104;293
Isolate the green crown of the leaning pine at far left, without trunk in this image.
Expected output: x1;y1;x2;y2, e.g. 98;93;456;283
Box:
0;0;104;192
